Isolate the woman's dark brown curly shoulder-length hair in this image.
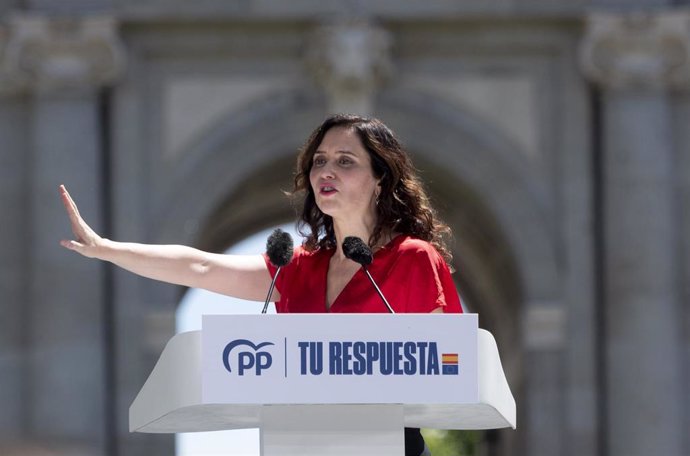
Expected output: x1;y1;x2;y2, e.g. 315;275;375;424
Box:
293;114;452;264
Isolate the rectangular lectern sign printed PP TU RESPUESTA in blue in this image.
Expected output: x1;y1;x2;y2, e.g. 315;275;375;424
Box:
202;314;478;404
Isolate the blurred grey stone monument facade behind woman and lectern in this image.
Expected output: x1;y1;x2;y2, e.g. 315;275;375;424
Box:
0;0;690;456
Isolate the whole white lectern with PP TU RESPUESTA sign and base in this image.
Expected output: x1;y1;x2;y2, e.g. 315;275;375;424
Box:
129;314;516;456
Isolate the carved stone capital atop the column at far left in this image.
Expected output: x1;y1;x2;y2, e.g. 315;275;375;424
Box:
2;16;125;92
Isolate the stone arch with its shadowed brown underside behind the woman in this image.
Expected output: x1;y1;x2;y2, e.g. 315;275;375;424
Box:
155;85;558;452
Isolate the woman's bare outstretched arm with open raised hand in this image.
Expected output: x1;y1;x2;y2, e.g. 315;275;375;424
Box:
60;185;280;301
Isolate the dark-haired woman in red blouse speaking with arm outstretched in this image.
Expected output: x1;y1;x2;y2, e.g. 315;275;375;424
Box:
60;115;462;456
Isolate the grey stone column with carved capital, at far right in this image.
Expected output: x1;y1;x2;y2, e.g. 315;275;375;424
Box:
582;13;690;456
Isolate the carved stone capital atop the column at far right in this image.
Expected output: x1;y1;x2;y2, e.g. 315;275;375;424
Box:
580;12;690;90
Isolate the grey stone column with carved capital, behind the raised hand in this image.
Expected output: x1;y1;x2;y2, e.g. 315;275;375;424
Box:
4;17;123;454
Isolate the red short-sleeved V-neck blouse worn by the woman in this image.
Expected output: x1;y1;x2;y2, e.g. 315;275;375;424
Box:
264;235;462;313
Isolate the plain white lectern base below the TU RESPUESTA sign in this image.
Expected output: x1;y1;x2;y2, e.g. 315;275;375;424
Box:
261;404;405;456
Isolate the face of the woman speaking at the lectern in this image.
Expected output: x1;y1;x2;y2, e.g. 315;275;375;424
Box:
309;127;379;224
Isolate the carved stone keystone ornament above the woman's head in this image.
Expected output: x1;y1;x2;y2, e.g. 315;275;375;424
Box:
306;22;392;114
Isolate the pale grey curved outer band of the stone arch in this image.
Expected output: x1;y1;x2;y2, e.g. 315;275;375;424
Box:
153;86;557;299
